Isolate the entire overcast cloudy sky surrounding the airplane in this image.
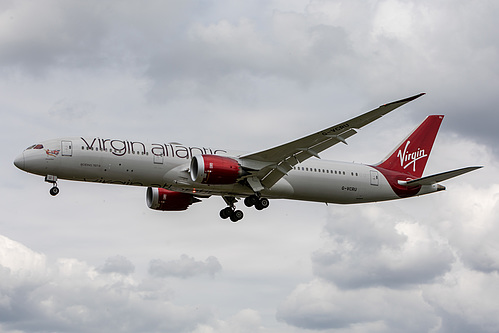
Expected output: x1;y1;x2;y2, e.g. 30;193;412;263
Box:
0;0;499;333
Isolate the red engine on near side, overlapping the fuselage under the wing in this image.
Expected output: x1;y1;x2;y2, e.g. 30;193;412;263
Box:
191;155;242;185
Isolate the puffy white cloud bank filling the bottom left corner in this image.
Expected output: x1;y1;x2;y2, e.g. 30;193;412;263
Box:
0;236;213;332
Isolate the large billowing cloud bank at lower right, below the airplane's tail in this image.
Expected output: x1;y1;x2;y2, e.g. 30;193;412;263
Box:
277;136;499;332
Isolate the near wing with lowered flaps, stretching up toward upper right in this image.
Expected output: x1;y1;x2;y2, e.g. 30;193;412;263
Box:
239;93;424;190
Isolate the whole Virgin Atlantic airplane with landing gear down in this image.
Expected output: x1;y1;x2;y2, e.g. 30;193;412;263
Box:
14;93;482;222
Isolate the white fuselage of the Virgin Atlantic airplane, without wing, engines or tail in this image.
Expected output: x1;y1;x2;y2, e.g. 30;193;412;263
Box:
15;137;437;204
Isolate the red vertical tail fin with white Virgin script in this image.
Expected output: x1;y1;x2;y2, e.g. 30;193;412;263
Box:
377;115;444;178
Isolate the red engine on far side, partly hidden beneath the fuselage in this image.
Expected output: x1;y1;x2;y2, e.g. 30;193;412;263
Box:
146;187;201;211
